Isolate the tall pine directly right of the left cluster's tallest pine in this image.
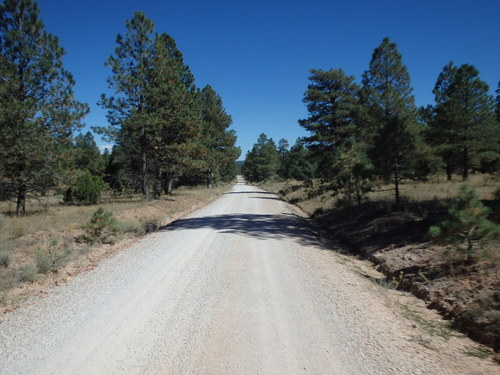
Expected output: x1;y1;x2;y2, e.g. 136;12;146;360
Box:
145;34;204;199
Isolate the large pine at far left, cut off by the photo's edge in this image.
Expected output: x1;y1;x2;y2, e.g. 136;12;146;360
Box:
0;0;88;216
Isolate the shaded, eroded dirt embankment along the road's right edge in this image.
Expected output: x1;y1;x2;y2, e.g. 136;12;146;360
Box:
273;182;500;353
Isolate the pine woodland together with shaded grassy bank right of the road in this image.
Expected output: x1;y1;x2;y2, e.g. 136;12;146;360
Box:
242;38;500;352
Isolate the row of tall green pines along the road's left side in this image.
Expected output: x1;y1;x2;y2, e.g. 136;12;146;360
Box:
0;0;240;216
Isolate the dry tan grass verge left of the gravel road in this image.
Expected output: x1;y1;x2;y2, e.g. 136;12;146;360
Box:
0;185;229;306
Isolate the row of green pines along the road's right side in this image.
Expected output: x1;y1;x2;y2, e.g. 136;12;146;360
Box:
243;38;500;209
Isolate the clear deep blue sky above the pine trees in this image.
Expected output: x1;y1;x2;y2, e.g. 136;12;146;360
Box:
38;0;500;159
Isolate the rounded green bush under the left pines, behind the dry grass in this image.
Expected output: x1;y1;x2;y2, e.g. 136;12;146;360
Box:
63;171;104;204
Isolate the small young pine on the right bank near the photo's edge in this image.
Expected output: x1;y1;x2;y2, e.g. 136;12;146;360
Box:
429;184;500;261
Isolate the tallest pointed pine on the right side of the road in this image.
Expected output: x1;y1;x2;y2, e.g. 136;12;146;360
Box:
361;38;421;206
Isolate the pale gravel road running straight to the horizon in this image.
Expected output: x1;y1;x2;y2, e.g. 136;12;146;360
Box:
0;183;498;375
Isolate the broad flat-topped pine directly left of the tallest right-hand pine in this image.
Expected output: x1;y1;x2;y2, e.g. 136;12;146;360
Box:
299;69;360;178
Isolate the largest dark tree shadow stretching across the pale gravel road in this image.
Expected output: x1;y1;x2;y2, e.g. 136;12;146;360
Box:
161;214;319;245
